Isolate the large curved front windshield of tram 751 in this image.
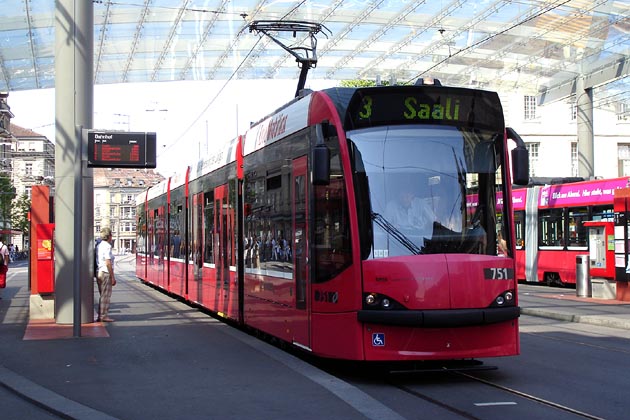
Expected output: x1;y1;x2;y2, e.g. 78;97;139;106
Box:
349;125;505;258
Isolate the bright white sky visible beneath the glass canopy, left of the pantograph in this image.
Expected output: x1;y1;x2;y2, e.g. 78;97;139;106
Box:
8;79;338;177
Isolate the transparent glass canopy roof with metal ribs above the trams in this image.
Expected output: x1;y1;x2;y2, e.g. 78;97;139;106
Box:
0;0;630;106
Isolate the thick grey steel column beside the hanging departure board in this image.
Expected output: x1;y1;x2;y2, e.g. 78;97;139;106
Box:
55;0;94;328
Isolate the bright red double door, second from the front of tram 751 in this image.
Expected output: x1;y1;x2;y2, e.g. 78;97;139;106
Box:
213;185;238;318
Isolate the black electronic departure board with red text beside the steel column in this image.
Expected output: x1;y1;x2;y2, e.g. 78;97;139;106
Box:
87;130;157;168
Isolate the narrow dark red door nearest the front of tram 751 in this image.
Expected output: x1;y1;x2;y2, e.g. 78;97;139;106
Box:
291;156;310;348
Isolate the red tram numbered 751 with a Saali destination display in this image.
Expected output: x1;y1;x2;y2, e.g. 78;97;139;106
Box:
136;85;528;361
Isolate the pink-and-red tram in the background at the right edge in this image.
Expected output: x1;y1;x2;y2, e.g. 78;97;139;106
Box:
512;177;630;285
